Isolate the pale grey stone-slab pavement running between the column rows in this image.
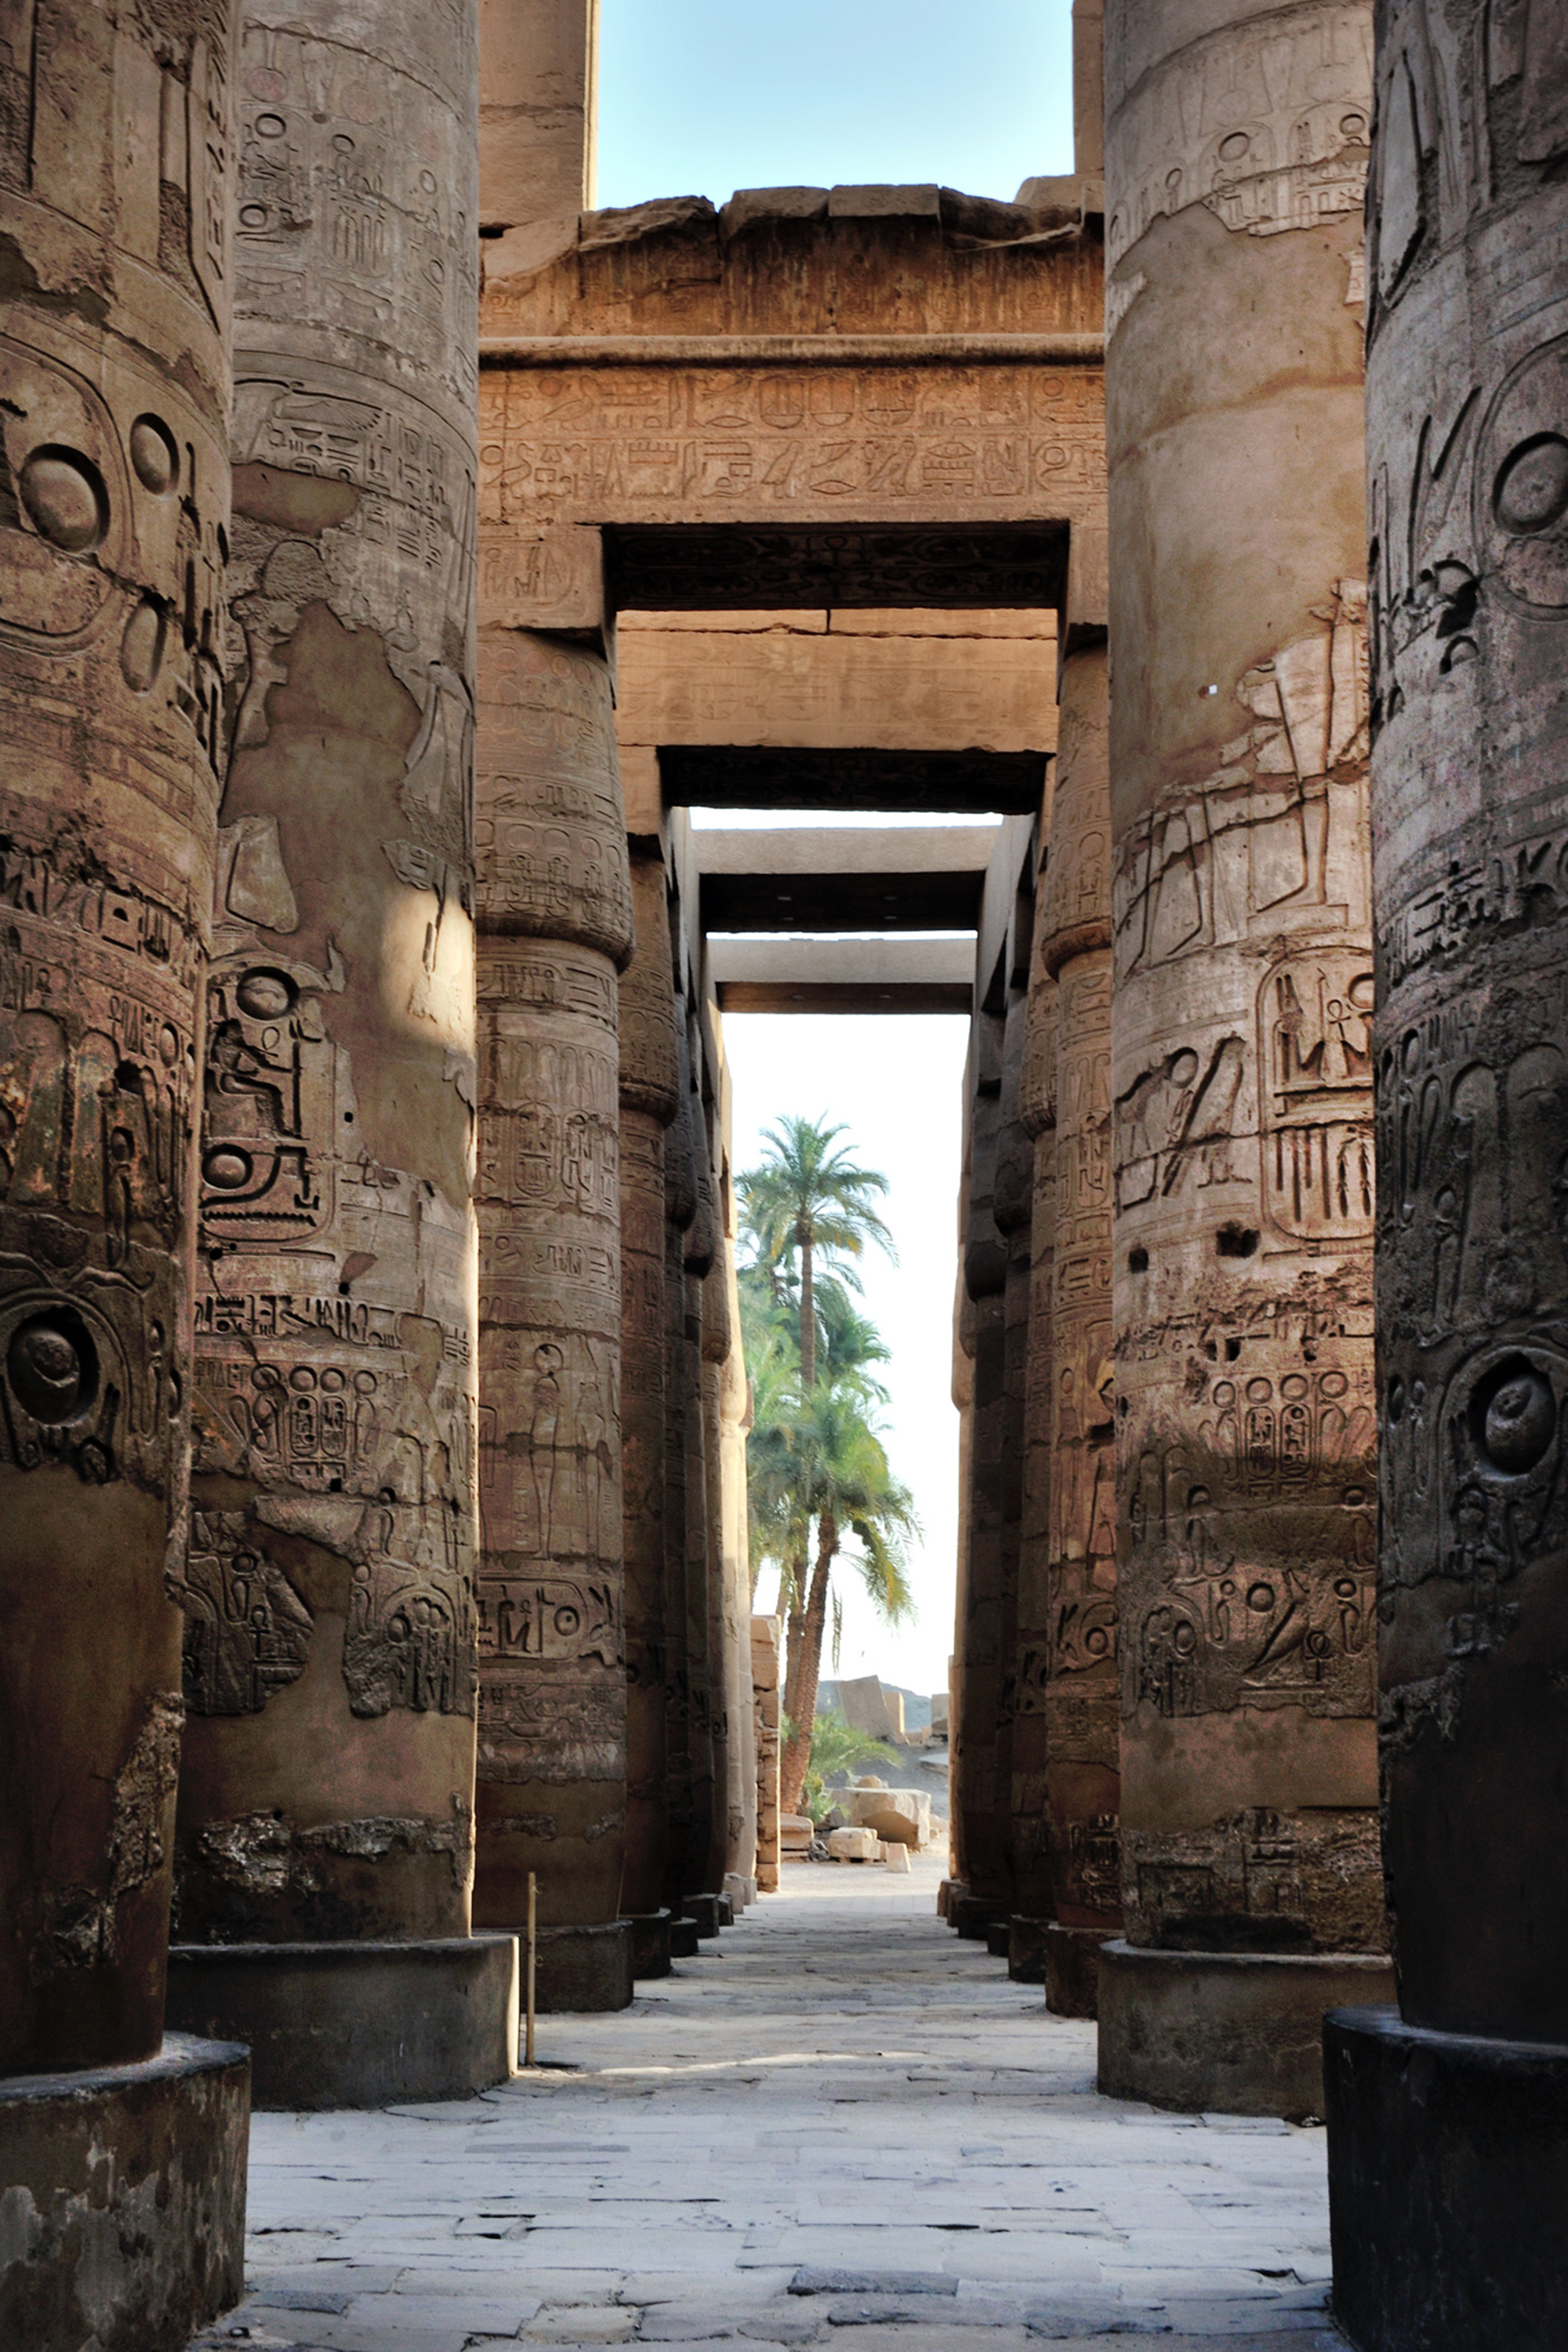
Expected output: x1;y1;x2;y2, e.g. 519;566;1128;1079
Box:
202;1858;1342;2352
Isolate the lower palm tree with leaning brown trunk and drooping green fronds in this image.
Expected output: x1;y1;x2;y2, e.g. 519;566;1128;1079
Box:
781;1381;919;1813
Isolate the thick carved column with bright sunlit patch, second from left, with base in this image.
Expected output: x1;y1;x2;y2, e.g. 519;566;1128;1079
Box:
172;0;510;2105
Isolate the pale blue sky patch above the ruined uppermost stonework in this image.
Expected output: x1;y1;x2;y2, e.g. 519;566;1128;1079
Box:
593;0;1072;205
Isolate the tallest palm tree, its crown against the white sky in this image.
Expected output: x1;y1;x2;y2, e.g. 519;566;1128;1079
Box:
739;1117;898;1390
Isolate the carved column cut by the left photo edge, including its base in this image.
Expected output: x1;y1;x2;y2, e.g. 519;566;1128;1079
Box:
0;0;247;2352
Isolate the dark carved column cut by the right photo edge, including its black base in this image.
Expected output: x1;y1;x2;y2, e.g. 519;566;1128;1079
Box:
1326;0;1568;2352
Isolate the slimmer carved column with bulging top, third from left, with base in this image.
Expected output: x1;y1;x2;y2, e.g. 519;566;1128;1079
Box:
475;628;633;2009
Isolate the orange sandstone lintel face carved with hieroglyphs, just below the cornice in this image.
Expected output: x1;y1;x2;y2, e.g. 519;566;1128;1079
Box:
480;365;1105;527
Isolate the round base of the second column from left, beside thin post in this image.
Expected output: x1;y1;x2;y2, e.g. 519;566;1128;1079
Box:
167;1936;520;2110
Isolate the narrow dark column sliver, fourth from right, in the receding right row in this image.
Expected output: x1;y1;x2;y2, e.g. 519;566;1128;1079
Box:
1008;887;1055;1983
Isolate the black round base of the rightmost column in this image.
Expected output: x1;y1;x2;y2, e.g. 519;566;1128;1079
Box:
1323;2009;1568;2352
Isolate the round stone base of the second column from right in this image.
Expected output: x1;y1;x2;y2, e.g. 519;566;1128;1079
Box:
1100;1940;1394;2119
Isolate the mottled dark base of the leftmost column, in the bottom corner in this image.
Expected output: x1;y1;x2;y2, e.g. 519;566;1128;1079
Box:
0;2034;249;2352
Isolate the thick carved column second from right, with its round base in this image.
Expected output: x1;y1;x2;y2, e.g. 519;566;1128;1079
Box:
1100;0;1389;2114
